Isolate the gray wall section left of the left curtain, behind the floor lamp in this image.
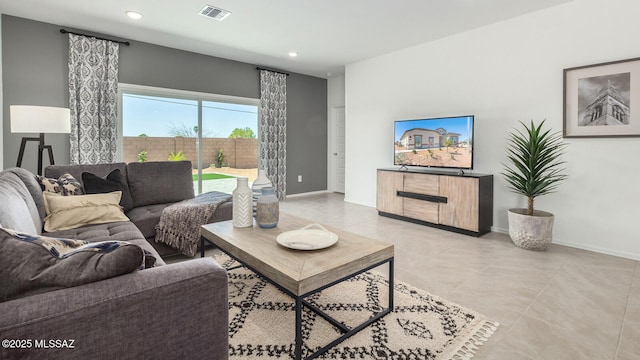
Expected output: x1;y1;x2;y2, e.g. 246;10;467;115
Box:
2;15;69;173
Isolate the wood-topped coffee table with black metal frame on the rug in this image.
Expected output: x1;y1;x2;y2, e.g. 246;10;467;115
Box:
201;213;394;359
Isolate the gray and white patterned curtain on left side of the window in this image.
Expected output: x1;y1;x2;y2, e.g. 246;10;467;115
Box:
69;34;120;164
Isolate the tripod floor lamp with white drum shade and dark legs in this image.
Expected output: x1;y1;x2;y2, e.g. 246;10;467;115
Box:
10;105;71;175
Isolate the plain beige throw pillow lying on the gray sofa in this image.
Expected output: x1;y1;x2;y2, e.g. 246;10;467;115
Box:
43;191;129;232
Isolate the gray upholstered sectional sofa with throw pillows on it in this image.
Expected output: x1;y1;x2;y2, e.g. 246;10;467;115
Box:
0;162;231;359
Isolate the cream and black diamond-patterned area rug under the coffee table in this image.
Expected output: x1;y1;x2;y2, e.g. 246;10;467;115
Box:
216;255;498;360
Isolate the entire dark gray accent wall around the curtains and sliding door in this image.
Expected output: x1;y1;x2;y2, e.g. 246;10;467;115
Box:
2;15;327;195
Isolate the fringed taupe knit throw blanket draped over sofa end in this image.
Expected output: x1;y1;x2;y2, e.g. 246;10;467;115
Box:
156;191;231;256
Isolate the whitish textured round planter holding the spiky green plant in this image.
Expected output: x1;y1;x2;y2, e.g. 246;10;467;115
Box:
508;209;554;251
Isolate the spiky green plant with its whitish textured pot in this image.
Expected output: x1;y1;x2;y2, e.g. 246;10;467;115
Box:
502;120;567;250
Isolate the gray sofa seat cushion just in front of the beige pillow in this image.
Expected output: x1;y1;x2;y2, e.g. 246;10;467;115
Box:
45;221;165;266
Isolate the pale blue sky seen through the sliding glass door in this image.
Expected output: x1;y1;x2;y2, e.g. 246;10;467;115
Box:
122;94;258;138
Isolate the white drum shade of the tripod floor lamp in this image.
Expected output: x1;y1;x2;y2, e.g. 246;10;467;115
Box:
9;105;71;133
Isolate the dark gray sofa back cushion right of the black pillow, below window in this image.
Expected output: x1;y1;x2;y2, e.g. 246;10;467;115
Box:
127;161;194;207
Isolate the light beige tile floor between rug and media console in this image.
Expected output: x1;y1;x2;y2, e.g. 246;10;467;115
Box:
176;193;640;360
